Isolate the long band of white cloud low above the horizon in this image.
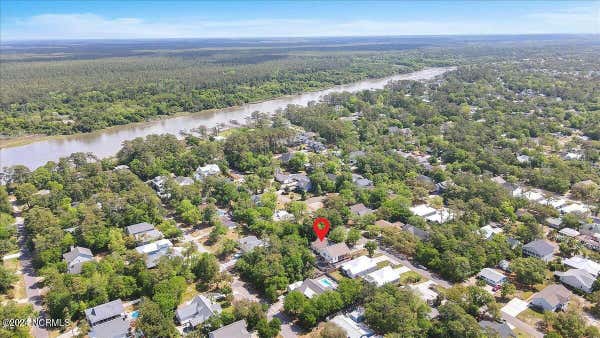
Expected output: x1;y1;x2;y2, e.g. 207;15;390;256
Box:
1;9;600;40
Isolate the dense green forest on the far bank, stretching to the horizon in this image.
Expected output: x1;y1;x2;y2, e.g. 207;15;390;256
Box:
0;37;593;137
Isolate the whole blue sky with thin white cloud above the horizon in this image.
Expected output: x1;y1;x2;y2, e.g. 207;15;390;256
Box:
0;0;600;41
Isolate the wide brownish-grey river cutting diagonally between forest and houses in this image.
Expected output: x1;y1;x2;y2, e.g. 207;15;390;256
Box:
0;67;454;169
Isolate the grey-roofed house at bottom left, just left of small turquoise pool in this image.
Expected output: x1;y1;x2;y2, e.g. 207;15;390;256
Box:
84;299;130;338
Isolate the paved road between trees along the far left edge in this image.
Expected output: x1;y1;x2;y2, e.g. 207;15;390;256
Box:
11;196;49;338
